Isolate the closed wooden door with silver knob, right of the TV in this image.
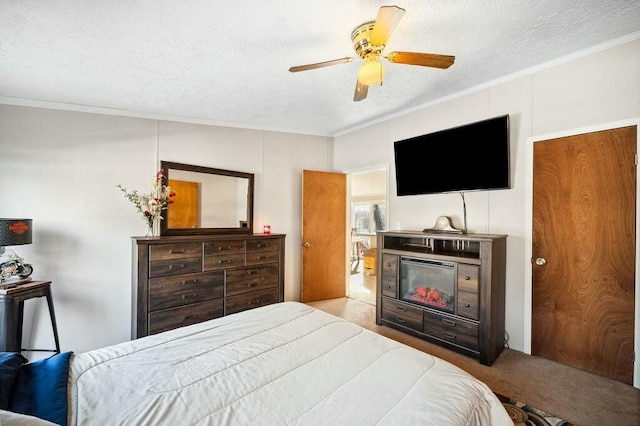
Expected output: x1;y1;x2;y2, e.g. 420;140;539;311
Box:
531;126;637;384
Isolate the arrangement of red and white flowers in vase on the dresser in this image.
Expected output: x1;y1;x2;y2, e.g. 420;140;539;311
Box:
116;169;176;235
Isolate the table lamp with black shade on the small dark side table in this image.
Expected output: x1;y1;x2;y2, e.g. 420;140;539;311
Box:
0;219;33;284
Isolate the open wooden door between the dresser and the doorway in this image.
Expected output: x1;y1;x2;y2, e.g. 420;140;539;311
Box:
302;170;347;302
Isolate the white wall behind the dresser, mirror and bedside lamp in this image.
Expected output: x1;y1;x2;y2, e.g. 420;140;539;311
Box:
0;105;331;359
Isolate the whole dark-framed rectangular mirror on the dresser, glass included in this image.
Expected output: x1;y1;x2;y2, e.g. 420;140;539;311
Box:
160;161;254;235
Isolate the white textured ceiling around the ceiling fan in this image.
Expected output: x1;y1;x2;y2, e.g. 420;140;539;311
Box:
0;0;640;136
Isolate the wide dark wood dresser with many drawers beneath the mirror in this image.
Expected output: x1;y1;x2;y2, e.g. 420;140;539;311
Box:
132;234;285;339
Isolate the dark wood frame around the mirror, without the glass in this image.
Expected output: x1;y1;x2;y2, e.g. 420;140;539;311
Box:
160;161;254;236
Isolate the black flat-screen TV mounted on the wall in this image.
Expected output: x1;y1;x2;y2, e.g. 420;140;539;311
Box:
393;114;511;196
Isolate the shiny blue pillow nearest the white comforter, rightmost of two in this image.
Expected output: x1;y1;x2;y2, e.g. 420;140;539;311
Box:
9;352;73;425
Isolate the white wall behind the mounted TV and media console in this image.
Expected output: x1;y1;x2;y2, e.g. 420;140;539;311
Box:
334;40;640;351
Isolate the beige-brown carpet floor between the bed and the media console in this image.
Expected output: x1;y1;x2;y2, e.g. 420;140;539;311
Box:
309;298;640;426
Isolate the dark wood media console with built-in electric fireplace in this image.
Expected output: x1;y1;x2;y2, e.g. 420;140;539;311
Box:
376;231;507;365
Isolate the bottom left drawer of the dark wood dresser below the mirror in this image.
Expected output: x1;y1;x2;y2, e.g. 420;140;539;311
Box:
149;299;224;334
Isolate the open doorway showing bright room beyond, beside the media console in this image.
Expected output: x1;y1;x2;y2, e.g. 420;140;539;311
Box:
347;167;387;305
